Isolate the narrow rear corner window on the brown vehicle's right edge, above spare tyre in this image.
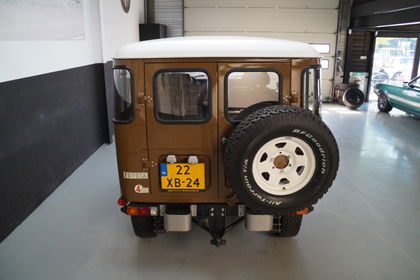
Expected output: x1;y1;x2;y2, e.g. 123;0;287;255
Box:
301;66;321;115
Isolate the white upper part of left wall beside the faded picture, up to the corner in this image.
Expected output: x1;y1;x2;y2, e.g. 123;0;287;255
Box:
0;0;102;82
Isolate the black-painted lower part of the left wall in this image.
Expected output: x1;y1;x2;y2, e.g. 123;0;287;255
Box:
0;64;112;241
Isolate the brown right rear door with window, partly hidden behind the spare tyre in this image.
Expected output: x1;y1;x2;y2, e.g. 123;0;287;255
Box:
218;59;291;196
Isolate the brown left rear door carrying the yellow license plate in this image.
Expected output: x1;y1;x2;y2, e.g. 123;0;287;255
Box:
144;63;218;202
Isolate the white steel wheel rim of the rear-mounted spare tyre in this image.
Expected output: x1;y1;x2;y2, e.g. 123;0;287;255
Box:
252;136;316;196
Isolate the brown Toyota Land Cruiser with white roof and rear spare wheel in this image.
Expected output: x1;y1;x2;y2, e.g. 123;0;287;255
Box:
113;37;339;246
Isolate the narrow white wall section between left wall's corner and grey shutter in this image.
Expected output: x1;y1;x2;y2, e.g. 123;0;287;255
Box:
99;0;144;62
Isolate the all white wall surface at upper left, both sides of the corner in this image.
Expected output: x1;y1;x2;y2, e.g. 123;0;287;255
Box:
0;0;143;82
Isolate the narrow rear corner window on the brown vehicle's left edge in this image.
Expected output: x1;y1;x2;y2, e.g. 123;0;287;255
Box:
113;66;134;123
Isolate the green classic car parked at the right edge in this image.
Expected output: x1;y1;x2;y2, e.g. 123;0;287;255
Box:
375;76;420;117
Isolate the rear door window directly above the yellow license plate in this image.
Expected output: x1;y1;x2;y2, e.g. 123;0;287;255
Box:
153;70;211;123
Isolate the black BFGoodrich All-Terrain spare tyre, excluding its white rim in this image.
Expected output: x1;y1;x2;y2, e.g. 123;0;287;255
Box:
225;105;339;215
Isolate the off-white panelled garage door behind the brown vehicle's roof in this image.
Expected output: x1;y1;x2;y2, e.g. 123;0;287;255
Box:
184;0;339;99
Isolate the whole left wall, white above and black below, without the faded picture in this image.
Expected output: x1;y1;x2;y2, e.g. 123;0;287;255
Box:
0;0;142;242
